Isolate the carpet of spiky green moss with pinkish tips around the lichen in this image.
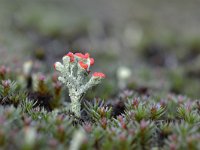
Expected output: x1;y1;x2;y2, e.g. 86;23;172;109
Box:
0;63;200;150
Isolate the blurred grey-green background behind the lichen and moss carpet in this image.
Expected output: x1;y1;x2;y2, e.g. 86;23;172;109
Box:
0;0;200;99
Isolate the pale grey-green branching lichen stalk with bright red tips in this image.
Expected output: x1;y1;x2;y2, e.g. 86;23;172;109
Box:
54;52;105;117
